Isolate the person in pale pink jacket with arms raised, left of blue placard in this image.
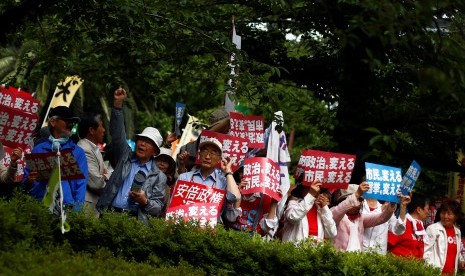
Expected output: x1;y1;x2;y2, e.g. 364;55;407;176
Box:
331;182;395;251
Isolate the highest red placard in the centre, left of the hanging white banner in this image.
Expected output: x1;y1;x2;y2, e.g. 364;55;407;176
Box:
229;112;265;149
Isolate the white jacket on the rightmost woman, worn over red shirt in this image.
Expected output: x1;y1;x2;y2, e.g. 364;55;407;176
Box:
423;222;464;272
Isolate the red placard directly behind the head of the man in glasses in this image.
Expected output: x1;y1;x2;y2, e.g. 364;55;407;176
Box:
195;130;249;171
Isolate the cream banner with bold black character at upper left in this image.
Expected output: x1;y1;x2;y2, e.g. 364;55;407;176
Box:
42;76;84;127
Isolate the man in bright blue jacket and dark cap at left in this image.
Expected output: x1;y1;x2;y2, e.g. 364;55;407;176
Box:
23;106;88;210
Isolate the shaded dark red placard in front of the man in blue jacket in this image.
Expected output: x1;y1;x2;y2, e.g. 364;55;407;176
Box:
26;149;84;180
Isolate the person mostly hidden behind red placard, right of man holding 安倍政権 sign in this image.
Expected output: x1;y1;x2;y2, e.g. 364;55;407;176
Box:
225;166;278;240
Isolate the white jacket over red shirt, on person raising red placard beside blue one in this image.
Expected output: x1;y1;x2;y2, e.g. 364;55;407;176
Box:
282;194;337;243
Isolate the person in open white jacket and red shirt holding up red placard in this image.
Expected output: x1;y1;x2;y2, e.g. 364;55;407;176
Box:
282;181;337;243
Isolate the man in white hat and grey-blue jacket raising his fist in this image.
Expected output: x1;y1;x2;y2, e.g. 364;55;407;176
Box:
97;88;167;224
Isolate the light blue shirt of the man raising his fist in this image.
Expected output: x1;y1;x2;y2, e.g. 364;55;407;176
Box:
112;158;152;211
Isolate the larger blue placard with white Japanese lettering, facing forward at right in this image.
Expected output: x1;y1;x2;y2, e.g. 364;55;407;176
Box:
364;162;402;203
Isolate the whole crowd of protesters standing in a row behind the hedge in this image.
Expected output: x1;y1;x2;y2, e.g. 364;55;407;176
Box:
0;88;465;274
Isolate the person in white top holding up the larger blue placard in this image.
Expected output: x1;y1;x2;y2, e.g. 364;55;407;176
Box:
362;192;411;255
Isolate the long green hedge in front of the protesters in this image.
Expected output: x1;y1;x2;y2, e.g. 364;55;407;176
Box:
0;193;439;275
